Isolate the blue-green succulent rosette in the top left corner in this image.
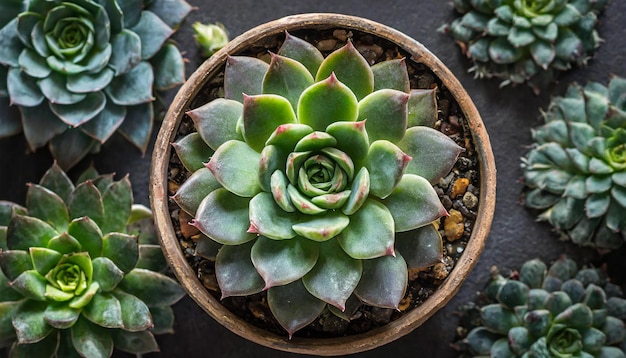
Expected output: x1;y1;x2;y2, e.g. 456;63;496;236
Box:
0;0;191;168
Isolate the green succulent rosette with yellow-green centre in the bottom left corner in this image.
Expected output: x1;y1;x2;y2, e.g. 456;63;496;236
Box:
0;164;184;357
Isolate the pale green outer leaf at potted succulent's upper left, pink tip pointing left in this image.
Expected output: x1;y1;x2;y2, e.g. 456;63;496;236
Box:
187;98;243;150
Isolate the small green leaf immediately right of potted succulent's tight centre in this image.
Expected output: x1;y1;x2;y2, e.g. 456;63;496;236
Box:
363;140;411;199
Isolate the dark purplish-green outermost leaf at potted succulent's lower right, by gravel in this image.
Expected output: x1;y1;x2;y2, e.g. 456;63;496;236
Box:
394;224;443;269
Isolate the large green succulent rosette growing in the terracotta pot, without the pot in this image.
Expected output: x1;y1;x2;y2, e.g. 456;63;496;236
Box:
174;34;462;336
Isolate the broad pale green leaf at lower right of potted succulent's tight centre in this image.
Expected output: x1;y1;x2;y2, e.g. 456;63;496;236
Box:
338;199;394;259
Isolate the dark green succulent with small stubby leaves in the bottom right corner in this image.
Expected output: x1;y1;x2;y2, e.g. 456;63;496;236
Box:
464;257;626;357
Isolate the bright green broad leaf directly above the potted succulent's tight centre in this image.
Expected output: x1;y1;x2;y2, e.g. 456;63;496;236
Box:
298;74;358;131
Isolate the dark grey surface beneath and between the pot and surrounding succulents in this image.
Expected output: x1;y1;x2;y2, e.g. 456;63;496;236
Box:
0;0;626;358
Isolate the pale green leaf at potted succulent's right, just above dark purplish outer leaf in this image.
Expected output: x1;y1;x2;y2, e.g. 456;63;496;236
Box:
383;174;447;232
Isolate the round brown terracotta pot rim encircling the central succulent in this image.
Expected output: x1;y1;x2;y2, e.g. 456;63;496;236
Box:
150;14;496;355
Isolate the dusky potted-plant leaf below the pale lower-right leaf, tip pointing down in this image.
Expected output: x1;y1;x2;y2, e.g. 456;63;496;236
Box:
354;252;408;309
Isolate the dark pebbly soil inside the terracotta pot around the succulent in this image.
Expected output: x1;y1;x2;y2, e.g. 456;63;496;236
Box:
168;29;480;338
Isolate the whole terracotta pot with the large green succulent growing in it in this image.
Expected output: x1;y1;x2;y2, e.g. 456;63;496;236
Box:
151;14;495;355
